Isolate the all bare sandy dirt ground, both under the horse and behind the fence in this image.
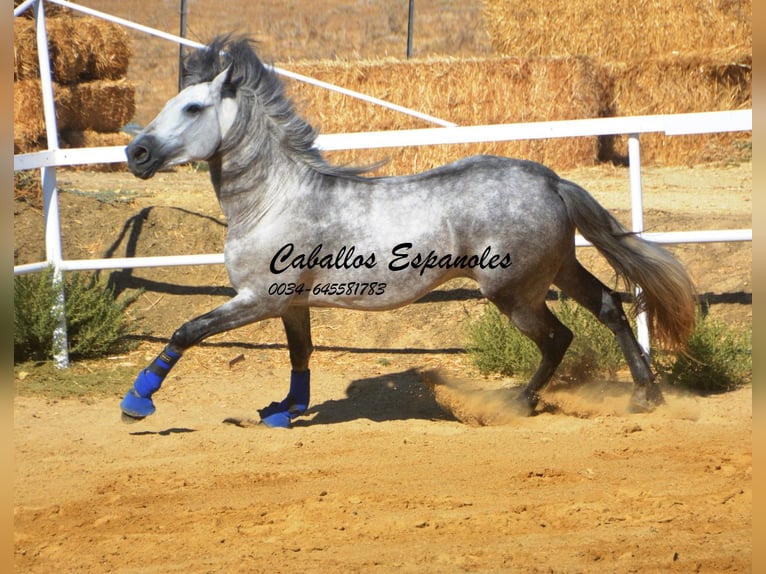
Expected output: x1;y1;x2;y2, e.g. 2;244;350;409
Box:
14;164;752;574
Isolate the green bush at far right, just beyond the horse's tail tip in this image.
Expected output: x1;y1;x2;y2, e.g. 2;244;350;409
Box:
652;315;753;393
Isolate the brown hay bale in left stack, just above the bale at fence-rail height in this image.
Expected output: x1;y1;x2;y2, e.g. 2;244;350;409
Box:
13;16;131;84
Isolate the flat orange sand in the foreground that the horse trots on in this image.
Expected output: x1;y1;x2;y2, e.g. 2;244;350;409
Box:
14;378;752;573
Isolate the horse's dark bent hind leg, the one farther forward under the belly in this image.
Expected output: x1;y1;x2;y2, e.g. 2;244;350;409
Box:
490;289;572;412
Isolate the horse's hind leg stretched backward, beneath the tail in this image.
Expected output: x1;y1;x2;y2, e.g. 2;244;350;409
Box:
554;255;664;411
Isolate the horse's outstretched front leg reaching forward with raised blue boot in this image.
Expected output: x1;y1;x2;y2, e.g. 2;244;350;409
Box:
120;295;280;422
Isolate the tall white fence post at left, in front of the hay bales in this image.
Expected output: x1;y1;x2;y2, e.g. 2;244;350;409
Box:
34;0;69;369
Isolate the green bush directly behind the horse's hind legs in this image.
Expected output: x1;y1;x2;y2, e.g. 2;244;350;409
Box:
468;299;625;379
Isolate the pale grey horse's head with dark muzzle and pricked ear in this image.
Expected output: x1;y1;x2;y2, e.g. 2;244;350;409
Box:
125;67;237;179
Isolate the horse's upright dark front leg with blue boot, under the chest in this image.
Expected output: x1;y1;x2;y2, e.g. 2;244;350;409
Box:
258;307;314;428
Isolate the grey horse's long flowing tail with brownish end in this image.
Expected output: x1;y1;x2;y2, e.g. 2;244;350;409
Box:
558;180;697;350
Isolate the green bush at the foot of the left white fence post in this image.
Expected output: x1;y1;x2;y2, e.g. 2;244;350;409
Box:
13;268;140;362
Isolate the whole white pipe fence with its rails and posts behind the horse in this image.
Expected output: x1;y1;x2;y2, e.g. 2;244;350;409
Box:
14;0;753;367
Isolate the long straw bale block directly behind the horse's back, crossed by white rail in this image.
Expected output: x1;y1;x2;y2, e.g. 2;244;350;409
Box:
287;57;608;174
